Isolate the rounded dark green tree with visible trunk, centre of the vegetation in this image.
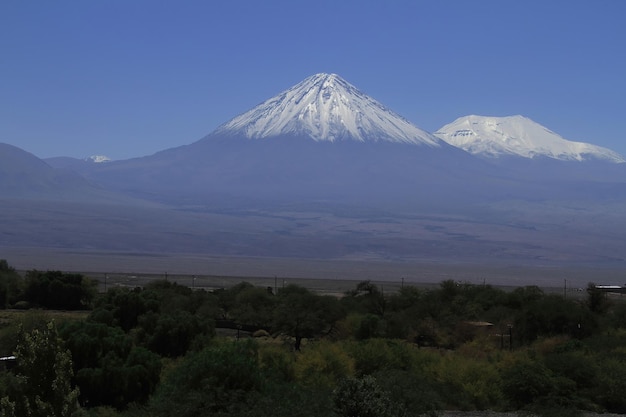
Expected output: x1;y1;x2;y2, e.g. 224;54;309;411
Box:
273;285;343;350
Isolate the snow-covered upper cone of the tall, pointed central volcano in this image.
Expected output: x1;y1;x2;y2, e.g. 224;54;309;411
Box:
213;74;440;146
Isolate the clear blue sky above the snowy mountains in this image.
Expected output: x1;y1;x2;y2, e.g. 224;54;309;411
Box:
0;0;626;159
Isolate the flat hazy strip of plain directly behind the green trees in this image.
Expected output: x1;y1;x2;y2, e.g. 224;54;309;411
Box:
0;247;626;294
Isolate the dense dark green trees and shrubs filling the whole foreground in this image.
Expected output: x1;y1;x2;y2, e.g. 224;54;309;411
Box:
0;261;626;417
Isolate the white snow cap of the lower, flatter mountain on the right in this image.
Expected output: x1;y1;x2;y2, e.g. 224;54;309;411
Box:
435;116;626;163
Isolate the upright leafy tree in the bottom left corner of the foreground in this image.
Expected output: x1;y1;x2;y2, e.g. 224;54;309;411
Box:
0;322;80;417
